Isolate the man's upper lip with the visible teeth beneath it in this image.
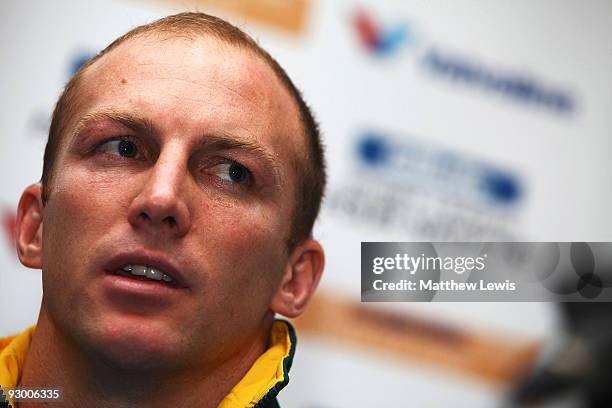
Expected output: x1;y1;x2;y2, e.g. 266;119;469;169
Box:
104;252;187;288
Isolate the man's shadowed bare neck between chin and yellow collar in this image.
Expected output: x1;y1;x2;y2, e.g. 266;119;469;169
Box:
19;303;273;408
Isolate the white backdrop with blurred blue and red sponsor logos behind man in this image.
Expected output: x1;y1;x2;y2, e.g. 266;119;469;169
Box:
0;0;612;407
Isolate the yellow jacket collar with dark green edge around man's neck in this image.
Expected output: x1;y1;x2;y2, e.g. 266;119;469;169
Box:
0;320;296;408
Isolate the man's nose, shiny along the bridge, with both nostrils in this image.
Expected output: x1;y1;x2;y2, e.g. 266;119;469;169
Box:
128;151;191;237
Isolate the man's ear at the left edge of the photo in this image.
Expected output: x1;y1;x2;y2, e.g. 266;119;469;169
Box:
16;184;43;269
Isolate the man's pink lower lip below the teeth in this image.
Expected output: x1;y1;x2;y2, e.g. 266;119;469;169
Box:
104;273;185;304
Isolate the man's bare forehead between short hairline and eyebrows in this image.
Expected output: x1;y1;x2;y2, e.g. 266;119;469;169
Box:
66;34;305;160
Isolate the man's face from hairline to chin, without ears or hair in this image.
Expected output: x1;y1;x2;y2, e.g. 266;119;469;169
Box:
42;38;304;366
